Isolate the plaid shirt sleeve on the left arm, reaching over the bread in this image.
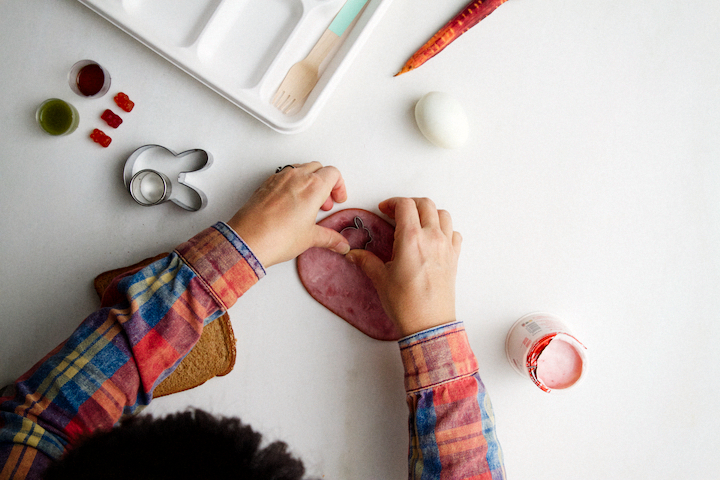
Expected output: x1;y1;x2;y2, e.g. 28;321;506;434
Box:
0;223;265;480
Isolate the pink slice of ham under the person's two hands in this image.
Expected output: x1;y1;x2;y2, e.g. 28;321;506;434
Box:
297;208;400;340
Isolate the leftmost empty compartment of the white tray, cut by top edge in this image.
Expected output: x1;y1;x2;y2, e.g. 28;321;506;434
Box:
120;0;222;47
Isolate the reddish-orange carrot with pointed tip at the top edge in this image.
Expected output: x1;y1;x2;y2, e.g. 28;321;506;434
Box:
395;0;507;77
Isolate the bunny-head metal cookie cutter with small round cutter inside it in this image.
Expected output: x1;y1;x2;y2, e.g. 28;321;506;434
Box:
123;145;212;212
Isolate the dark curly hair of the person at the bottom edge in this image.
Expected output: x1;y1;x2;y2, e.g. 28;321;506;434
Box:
44;409;305;480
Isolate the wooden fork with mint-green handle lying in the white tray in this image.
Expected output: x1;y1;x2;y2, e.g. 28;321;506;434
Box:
270;0;368;115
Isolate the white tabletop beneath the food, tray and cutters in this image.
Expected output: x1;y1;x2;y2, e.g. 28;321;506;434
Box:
0;0;720;479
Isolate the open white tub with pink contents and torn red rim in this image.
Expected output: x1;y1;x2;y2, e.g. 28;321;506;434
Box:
505;312;587;393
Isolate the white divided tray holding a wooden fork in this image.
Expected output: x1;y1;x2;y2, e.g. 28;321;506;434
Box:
79;0;391;133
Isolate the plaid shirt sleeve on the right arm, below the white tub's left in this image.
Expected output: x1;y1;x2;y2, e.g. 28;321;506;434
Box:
399;322;505;480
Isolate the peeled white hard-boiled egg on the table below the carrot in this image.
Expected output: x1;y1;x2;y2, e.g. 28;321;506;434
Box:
415;92;470;148
